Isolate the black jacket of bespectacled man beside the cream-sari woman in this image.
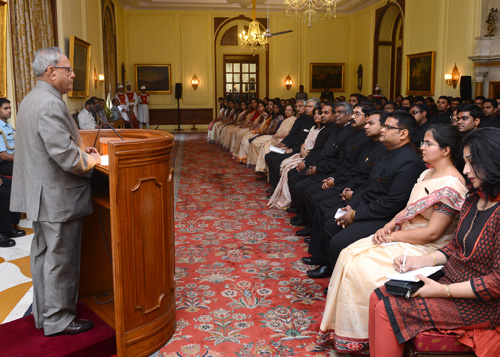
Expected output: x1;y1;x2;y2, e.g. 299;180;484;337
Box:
349;144;425;221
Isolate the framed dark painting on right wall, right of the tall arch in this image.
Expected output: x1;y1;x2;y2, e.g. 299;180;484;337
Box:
406;51;436;95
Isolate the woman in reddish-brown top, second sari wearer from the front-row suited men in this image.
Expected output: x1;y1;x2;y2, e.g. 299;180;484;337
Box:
238;100;285;166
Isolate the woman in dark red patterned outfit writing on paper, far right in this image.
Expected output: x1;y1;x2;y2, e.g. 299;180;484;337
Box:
370;128;500;356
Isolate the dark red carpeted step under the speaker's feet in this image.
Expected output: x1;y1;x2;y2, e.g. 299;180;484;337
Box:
0;303;116;357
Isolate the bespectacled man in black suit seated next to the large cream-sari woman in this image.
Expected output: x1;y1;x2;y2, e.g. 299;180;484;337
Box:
307;111;425;278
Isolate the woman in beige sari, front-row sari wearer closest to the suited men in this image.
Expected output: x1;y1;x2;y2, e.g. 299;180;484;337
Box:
254;104;297;172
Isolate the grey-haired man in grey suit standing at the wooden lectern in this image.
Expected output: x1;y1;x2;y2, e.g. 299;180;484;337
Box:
10;47;101;336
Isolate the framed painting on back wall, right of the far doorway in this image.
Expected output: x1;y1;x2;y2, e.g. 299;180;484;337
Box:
309;63;345;92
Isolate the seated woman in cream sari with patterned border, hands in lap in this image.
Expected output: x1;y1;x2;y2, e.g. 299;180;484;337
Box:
317;125;467;353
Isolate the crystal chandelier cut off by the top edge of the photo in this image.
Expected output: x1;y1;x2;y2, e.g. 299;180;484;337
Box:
283;0;338;27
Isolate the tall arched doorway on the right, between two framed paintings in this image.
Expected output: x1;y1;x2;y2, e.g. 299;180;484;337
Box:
373;0;404;99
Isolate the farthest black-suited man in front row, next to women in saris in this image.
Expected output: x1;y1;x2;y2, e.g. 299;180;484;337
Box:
266;98;319;197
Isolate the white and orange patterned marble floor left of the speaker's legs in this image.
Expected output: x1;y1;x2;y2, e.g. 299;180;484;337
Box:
0;219;33;324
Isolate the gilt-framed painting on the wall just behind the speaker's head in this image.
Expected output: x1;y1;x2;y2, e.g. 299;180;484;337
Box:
68;36;91;98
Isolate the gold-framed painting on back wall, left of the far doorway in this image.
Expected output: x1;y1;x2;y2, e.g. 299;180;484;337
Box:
134;64;172;94
